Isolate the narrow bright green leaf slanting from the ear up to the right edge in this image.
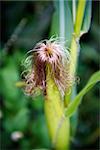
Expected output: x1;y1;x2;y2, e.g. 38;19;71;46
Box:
65;71;100;117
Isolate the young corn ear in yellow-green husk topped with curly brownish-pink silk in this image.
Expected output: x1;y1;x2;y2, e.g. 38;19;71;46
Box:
22;38;72;149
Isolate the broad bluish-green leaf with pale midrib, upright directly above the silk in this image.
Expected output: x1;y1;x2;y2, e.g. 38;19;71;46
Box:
50;0;73;46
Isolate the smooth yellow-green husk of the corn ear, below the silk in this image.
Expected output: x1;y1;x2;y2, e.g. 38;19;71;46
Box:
45;69;70;150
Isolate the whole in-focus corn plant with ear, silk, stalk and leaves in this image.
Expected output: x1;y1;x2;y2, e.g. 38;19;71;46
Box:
21;0;100;150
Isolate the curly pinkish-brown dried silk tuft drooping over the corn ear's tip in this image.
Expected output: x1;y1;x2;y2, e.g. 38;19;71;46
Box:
23;38;73;96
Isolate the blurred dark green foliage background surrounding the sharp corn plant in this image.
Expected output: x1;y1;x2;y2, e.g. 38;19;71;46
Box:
0;1;100;150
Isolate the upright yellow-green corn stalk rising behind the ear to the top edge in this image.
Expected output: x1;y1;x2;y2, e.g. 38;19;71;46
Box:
65;0;86;106
